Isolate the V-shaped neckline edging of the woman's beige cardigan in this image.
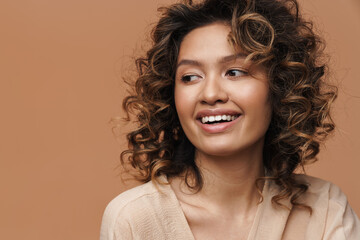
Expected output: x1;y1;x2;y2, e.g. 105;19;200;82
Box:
160;175;269;240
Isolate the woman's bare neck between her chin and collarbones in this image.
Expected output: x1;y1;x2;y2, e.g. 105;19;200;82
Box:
196;149;264;215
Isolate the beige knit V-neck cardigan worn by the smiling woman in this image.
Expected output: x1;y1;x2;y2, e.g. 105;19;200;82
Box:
100;175;360;240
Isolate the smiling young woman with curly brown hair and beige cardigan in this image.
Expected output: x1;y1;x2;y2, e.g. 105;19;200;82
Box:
101;0;360;240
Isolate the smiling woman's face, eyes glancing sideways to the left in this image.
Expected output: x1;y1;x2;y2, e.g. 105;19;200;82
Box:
175;23;271;156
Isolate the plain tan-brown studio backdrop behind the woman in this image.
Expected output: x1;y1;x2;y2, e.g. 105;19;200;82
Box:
0;0;360;240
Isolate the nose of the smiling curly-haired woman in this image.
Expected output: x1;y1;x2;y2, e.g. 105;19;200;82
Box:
199;76;229;105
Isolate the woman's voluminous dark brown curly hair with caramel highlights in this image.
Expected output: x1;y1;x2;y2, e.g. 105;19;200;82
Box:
121;0;337;212
